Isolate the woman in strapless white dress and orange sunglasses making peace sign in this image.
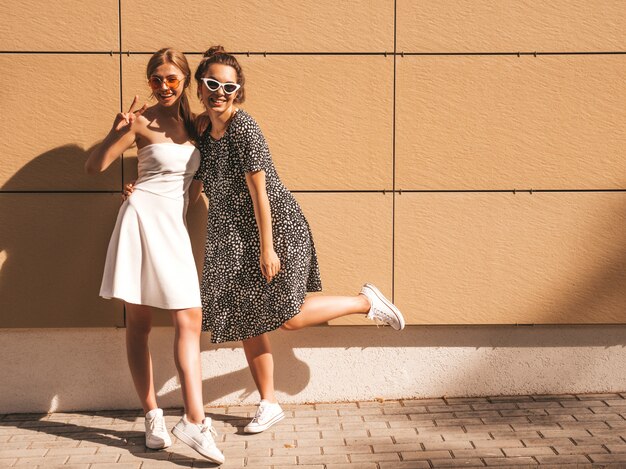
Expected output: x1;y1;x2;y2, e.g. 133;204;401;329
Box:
85;49;224;463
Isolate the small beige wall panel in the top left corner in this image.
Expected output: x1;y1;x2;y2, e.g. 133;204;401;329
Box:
0;0;119;51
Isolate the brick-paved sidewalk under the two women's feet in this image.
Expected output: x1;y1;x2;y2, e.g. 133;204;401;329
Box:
0;393;626;469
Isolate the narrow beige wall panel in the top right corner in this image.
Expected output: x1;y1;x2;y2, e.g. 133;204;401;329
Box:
397;0;626;52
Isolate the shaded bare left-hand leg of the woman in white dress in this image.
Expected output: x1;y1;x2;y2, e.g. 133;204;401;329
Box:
126;303;158;413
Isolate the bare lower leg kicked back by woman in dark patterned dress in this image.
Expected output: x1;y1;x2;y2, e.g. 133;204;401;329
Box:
281;295;370;331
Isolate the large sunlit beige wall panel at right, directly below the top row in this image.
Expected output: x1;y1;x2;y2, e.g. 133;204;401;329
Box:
396;56;626;189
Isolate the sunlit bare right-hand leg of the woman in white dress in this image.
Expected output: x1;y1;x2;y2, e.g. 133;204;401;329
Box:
170;308;204;423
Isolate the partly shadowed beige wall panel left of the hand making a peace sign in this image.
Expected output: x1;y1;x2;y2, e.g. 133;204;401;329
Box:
0;55;121;190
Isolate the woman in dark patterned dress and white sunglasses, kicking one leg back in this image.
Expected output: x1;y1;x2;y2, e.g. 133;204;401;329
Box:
192;46;404;433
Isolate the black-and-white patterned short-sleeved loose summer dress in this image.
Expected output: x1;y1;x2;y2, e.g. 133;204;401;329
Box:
194;109;322;343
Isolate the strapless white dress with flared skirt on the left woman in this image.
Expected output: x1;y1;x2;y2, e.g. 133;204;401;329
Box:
100;143;201;309
